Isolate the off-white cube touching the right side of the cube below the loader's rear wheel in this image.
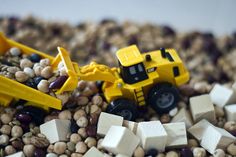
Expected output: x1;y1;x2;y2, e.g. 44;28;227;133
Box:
163;122;188;148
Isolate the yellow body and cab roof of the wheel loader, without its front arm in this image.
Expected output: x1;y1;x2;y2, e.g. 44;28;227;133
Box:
100;46;189;106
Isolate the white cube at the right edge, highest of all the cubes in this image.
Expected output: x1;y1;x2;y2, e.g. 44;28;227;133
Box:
210;84;236;108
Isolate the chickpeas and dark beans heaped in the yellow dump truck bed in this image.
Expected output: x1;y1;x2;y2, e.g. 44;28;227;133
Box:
0;47;73;104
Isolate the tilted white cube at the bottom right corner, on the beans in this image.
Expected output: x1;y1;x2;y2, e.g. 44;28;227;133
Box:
200;126;235;154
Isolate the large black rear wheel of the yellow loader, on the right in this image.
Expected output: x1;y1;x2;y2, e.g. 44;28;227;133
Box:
148;83;179;114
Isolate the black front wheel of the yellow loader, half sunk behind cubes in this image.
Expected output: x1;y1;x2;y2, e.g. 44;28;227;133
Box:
106;99;138;120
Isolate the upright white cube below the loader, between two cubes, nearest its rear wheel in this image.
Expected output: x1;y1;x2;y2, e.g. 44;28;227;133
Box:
136;121;167;152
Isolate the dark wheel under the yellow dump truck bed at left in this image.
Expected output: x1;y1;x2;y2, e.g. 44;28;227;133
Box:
19;106;46;125
